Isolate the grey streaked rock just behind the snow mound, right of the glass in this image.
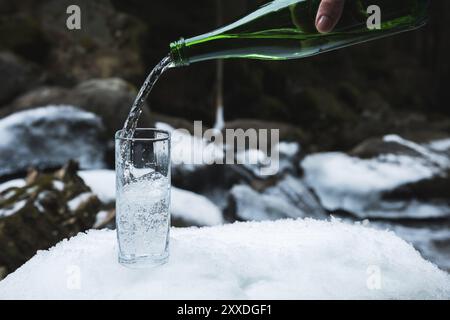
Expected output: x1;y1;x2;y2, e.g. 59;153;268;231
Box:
225;175;326;221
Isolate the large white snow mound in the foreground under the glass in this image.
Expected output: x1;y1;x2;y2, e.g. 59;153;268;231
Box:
0;219;450;299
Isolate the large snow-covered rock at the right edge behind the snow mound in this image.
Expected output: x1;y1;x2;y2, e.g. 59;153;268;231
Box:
301;136;450;218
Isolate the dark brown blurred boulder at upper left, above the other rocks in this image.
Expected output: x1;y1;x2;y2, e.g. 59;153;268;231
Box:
38;0;146;83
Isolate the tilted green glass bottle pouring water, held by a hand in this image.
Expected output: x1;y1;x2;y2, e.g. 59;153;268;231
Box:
170;0;429;66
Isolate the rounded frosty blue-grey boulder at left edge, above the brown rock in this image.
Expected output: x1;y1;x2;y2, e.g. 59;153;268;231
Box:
0;106;106;176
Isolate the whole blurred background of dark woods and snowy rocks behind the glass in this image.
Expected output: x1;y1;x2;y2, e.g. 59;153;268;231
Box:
0;0;450;279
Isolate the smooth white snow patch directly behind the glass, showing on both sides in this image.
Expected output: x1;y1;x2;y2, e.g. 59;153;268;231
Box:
79;170;223;226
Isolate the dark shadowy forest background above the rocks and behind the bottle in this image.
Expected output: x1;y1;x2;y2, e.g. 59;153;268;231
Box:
0;0;450;151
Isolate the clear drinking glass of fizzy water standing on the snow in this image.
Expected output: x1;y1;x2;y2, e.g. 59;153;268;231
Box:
116;129;170;268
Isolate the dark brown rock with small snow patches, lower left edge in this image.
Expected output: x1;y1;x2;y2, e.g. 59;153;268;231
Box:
0;162;101;273
